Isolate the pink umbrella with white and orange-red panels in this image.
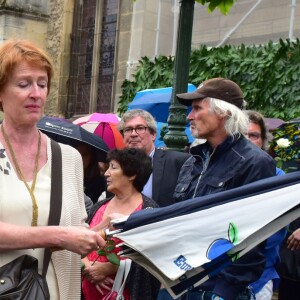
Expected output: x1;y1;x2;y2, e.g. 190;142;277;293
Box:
73;113;125;149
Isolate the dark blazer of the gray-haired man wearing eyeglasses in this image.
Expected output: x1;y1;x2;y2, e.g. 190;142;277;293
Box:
152;148;190;207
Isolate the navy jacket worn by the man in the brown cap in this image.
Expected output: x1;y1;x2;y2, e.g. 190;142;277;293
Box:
174;136;276;300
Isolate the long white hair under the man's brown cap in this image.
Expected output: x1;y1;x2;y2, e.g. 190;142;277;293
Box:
203;98;249;136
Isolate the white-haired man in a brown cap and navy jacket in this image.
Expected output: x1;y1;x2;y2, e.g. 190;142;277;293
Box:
158;78;275;300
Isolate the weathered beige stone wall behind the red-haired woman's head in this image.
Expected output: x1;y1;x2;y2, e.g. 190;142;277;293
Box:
0;0;74;115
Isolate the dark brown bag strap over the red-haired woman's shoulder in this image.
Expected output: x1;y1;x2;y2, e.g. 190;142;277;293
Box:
42;139;62;278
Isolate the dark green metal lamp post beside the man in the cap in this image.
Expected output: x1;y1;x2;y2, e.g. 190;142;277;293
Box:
164;0;195;151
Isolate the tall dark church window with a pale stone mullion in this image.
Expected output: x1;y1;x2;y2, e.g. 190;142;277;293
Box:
67;0;118;118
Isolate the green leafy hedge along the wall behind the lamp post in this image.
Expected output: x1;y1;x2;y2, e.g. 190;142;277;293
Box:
118;39;300;120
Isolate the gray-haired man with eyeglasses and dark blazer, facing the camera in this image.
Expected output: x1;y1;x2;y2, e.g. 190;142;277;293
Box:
118;109;189;207
